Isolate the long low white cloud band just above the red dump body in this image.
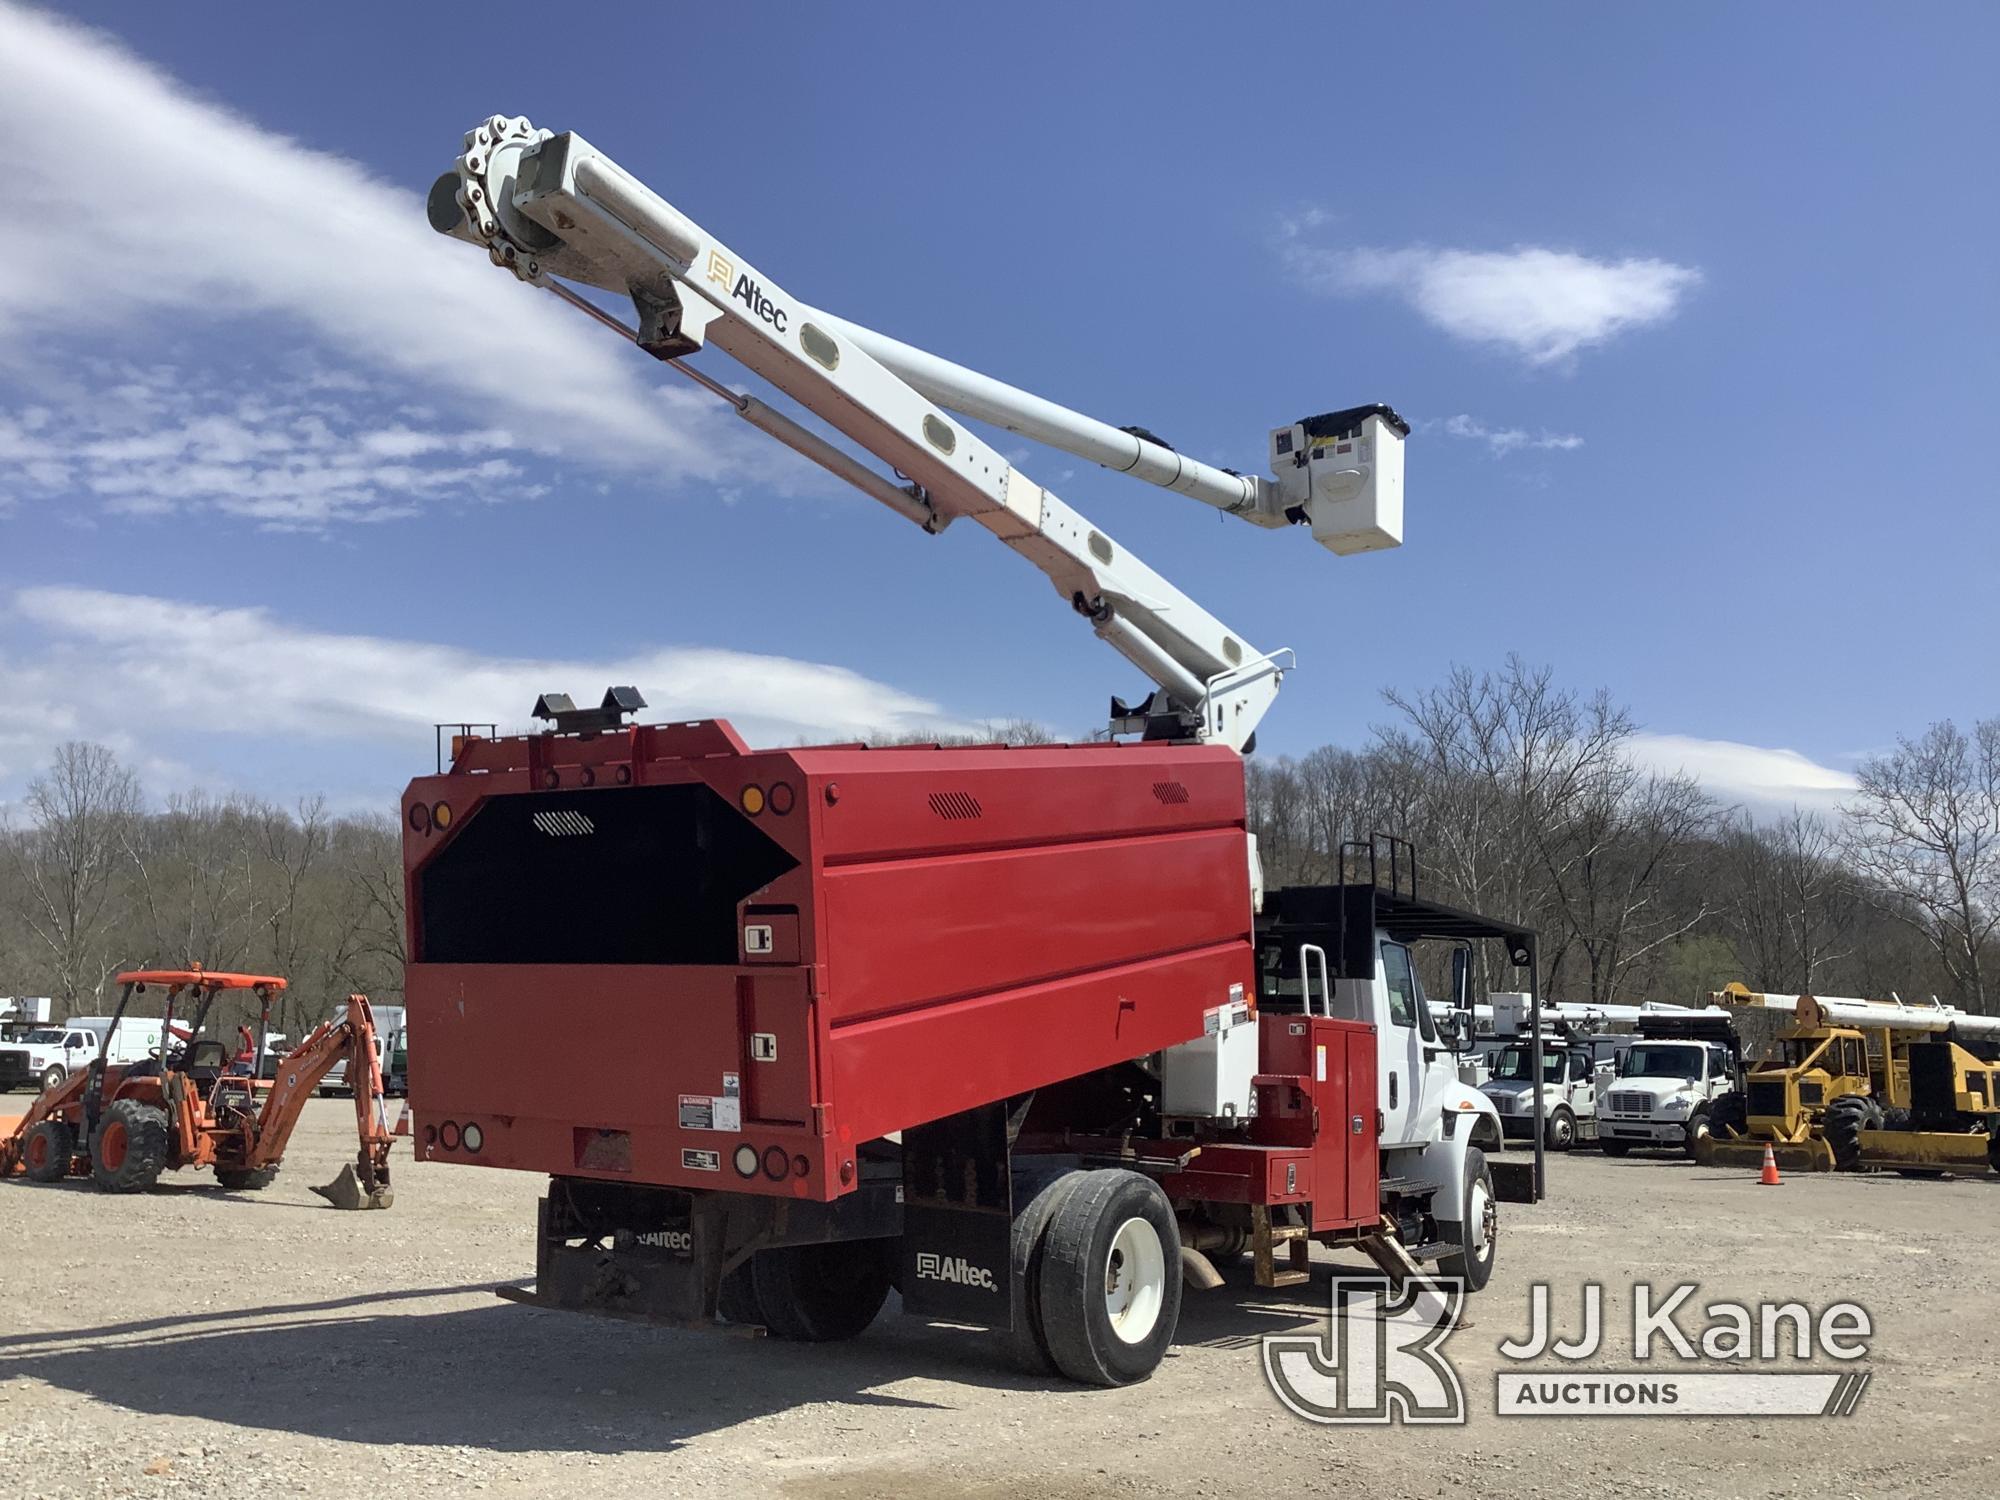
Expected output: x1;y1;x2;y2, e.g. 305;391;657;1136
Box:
0;588;968;800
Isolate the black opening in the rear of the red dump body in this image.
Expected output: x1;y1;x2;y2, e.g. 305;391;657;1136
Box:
414;782;798;964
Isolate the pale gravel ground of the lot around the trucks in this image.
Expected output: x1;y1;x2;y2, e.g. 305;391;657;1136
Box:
0;1096;2000;1500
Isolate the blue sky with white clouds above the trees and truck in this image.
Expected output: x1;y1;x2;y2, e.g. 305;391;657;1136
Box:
0;0;2000;824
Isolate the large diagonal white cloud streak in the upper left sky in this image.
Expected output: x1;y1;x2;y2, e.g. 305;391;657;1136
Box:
0;0;774;480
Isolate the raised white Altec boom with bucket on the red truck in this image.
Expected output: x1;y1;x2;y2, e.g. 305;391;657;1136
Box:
430;116;1408;750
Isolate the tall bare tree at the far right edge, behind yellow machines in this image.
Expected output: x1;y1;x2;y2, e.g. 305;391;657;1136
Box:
1848;718;2000;1010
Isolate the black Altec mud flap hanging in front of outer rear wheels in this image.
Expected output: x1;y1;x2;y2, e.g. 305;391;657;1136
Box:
896;1102;1014;1328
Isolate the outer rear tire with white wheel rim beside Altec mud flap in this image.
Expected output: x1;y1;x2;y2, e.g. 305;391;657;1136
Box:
1038;1168;1180;1386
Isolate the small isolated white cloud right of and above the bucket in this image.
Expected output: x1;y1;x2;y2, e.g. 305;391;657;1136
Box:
1280;229;1702;364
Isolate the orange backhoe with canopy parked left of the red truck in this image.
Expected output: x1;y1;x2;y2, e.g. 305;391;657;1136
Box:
0;968;394;1208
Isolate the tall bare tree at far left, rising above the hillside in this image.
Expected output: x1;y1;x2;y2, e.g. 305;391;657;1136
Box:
10;740;140;1012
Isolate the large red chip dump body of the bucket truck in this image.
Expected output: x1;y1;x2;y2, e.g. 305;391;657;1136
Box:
404;722;1254;1198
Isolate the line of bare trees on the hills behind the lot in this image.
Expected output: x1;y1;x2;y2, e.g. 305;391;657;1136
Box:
0;658;2000;1036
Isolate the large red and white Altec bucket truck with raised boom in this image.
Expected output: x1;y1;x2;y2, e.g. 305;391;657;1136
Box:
414;116;1540;1384
